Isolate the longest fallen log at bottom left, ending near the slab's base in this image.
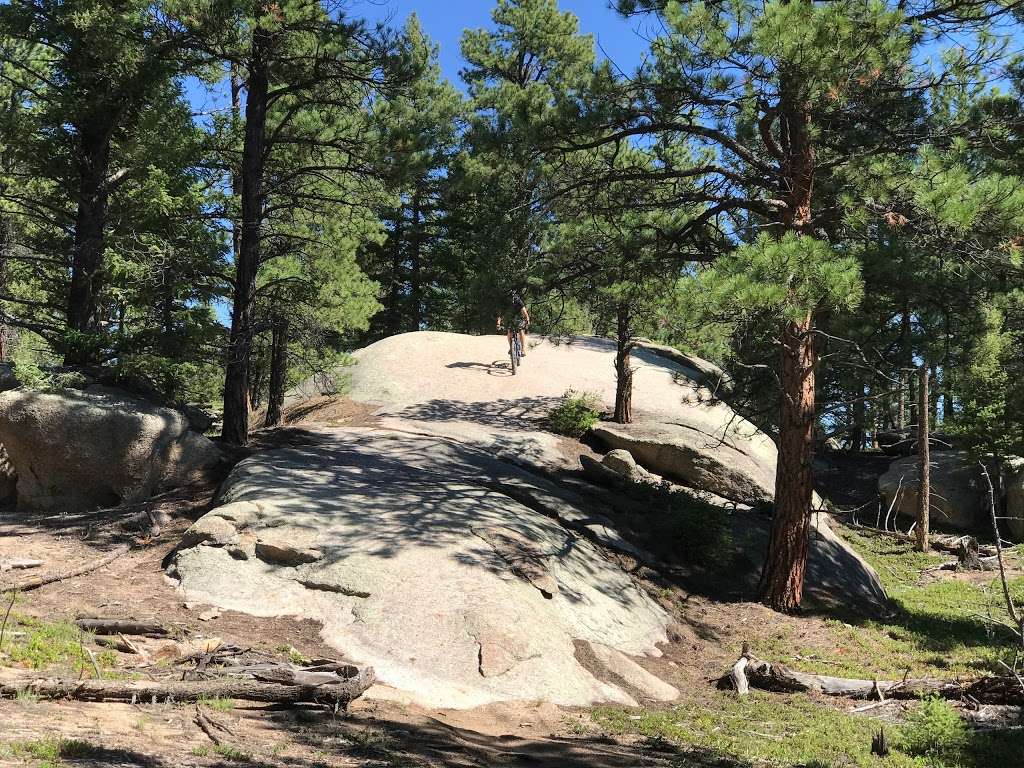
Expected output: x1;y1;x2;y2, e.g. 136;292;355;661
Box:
0;667;376;709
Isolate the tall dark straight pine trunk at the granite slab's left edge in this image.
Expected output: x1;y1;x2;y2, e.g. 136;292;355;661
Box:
222;27;271;445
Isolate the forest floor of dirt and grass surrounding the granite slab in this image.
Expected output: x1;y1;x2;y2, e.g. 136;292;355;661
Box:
0;423;1024;768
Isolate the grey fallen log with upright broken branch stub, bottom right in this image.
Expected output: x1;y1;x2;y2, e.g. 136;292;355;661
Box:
722;654;1024;705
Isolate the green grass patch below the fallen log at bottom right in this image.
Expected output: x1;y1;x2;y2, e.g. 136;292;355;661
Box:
591;692;1024;768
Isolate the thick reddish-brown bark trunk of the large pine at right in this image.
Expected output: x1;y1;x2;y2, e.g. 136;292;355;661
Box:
760;72;817;612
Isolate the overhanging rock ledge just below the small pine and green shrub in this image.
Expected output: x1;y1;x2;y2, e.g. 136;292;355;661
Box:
591;421;775;504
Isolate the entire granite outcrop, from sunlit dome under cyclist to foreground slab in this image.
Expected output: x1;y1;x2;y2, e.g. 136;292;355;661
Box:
169;333;883;708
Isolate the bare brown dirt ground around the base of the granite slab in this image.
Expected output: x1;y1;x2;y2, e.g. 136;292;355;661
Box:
0;475;860;768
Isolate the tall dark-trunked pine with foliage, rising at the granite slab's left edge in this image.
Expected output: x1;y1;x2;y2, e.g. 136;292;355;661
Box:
175;0;415;444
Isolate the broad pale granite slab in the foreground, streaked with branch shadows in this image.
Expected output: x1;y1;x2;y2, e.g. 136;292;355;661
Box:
170;428;672;708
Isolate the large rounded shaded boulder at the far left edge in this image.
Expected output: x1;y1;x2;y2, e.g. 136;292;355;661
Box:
0;387;222;512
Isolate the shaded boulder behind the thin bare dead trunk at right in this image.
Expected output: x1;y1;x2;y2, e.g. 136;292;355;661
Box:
879;451;988;531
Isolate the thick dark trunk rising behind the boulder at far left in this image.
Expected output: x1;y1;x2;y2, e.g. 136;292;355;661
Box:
65;130;111;366
